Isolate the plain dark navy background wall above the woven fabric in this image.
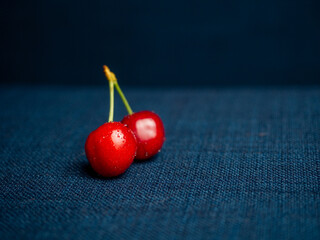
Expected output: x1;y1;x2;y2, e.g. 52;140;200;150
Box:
0;0;320;86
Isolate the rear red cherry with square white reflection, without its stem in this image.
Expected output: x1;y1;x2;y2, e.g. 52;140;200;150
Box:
121;111;165;160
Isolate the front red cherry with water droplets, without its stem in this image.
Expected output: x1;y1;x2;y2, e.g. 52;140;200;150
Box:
85;122;137;177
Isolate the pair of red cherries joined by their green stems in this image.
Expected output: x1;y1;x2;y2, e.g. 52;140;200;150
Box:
85;65;165;177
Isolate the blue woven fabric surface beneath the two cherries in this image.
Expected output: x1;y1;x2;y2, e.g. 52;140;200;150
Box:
0;87;320;239
